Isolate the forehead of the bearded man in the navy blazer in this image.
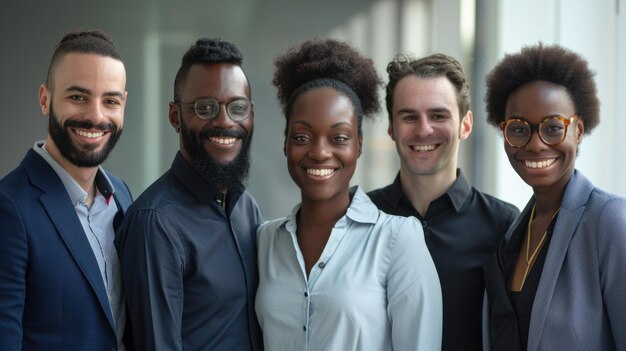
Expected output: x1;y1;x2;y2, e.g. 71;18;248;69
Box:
54;53;126;92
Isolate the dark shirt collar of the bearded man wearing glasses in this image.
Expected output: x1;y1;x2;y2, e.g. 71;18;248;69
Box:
171;151;242;203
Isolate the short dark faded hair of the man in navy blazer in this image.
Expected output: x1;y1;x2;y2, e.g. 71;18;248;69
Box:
46;30;122;89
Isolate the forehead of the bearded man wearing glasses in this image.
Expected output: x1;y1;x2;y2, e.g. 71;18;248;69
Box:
182;63;250;102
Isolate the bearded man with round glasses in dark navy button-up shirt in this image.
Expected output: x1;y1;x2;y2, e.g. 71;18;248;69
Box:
119;39;262;351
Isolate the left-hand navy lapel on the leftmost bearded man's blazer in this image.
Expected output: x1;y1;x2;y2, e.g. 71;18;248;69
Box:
22;150;115;327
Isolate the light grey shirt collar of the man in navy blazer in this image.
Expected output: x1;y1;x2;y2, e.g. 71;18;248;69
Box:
33;140;115;206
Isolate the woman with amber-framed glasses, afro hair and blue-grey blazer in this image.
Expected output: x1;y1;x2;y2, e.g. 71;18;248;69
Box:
485;44;626;351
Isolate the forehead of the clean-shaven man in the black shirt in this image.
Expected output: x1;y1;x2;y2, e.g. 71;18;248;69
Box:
393;75;458;111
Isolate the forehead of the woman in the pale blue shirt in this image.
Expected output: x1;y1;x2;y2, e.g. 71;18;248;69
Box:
289;88;356;125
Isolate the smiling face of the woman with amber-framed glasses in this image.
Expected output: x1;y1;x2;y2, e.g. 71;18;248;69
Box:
504;81;584;192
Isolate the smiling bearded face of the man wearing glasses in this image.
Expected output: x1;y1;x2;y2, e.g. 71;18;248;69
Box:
169;63;254;190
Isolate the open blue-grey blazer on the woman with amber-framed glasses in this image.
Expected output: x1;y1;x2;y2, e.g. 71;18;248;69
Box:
485;171;626;351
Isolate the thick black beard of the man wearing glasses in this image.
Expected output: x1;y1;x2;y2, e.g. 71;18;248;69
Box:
180;119;252;191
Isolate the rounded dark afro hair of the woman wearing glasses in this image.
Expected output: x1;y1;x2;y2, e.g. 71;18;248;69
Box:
485;43;600;133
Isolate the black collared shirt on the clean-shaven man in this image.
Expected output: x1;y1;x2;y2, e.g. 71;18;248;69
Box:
368;170;519;351
